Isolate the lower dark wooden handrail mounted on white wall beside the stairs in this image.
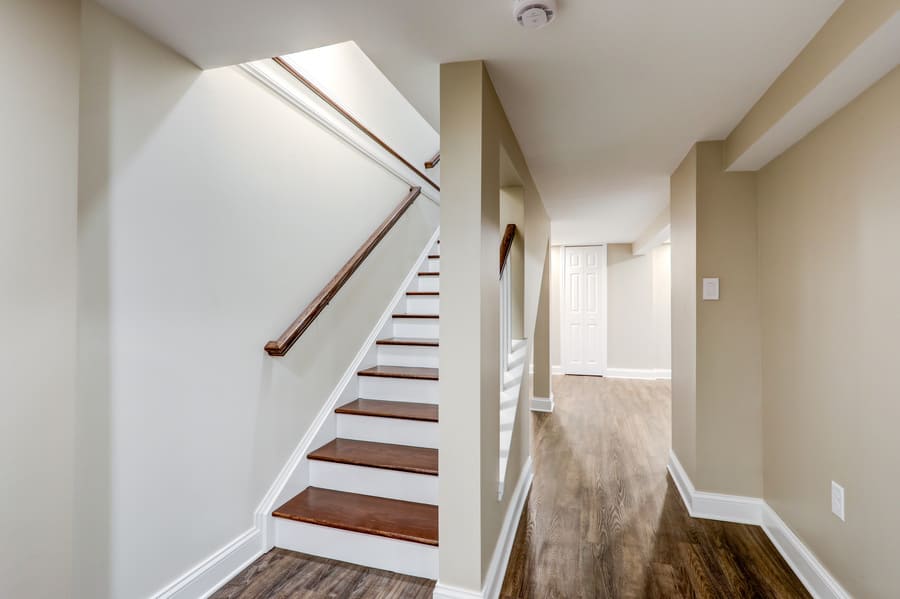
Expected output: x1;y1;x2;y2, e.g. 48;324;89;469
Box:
266;187;422;356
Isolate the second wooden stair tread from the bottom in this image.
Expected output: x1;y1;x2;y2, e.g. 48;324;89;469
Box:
307;439;438;476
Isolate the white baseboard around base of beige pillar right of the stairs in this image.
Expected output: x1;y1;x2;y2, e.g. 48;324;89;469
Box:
433;456;534;599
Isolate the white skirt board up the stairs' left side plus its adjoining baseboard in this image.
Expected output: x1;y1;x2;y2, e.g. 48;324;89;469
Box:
151;228;441;599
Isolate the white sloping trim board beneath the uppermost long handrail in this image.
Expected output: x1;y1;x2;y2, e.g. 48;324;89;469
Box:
239;59;441;205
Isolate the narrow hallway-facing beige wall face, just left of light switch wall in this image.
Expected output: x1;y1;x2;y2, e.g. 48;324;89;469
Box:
670;146;697;478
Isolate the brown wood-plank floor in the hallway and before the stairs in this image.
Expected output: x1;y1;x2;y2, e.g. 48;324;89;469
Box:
213;377;809;599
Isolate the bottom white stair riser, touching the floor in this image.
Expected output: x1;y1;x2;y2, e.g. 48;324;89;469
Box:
275;518;438;580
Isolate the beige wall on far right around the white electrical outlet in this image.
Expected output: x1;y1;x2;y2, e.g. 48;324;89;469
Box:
758;69;900;599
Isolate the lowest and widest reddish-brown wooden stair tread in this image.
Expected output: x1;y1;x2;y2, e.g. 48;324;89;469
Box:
272;487;438;547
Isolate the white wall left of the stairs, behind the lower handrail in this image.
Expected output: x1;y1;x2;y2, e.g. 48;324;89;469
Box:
79;3;438;597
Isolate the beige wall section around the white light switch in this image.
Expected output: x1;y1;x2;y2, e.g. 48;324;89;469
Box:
693;142;762;497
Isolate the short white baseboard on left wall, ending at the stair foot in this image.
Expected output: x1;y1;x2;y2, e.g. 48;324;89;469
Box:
151;526;267;599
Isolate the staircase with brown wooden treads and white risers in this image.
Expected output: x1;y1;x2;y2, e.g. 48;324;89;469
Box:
272;242;440;579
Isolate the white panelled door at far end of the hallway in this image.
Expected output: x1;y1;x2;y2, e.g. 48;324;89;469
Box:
562;245;606;375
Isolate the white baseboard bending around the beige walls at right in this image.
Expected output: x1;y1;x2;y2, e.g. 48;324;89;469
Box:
669;451;850;599
